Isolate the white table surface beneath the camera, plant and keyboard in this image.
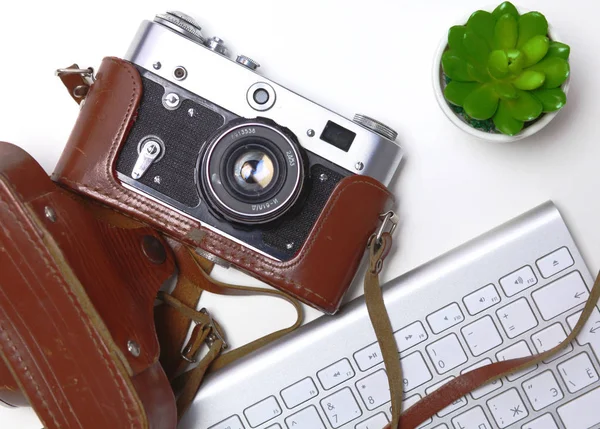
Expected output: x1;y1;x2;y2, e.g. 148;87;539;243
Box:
0;0;600;429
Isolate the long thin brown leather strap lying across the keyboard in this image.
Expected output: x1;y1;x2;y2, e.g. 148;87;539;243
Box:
364;233;600;429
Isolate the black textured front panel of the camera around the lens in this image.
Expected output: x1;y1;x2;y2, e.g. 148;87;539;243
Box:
116;68;352;261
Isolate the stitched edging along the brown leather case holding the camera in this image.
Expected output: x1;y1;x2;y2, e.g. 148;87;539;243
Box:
60;59;387;306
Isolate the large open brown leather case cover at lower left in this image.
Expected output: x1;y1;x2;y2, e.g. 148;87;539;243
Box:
0;143;176;429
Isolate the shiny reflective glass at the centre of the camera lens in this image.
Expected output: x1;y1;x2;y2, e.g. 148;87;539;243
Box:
233;150;275;193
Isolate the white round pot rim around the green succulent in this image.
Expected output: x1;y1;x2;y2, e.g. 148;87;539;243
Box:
432;8;570;143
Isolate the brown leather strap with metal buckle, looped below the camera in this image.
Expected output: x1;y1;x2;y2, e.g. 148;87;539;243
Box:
72;183;303;417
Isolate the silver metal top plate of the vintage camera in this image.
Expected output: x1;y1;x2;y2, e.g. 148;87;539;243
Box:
125;21;402;186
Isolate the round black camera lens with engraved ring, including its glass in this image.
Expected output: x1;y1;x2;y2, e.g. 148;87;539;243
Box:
198;118;305;224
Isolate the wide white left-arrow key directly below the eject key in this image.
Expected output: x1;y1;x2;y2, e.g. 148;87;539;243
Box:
531;271;590;320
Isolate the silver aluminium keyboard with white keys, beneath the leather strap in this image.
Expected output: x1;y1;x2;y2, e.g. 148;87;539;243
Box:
179;203;600;429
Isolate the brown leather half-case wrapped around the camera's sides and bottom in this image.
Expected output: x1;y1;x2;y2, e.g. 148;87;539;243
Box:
53;58;392;313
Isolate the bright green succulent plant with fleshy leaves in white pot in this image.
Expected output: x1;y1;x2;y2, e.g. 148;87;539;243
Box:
442;2;570;135
